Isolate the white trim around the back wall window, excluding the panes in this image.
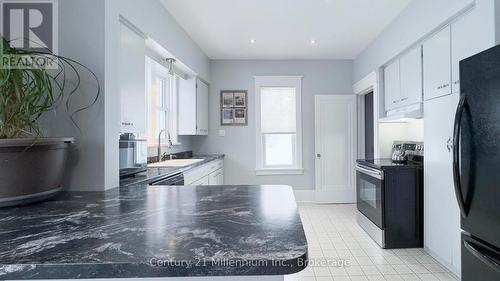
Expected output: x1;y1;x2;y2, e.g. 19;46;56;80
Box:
254;76;304;176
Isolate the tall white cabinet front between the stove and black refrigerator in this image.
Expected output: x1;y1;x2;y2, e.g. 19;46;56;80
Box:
424;94;460;274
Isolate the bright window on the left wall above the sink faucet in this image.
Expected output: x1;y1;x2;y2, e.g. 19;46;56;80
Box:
146;58;179;146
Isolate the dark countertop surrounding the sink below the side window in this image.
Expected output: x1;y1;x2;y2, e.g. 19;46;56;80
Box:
120;154;224;187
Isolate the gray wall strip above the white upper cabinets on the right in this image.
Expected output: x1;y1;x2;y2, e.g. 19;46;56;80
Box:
354;0;484;82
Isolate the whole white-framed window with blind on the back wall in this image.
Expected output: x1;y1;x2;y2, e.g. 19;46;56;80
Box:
255;76;303;175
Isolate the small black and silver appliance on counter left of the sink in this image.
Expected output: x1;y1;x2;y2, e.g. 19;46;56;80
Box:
120;139;148;178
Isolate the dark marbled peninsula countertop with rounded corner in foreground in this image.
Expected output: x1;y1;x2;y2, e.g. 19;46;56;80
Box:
0;183;307;279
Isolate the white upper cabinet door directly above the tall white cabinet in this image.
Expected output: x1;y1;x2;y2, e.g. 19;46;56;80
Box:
423;26;451;100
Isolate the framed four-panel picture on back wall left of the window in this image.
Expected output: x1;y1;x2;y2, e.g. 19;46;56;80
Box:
220;90;248;126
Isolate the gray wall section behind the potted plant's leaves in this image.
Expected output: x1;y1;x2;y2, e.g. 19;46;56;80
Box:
42;0;106;190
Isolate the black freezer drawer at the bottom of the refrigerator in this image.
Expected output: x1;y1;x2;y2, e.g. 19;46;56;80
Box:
462;234;500;281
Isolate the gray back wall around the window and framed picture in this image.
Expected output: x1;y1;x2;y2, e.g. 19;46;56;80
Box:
194;60;353;189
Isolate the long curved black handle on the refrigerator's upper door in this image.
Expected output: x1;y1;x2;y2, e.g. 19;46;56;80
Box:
453;94;468;218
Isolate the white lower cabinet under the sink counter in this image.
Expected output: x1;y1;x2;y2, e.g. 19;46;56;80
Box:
184;159;224;185
